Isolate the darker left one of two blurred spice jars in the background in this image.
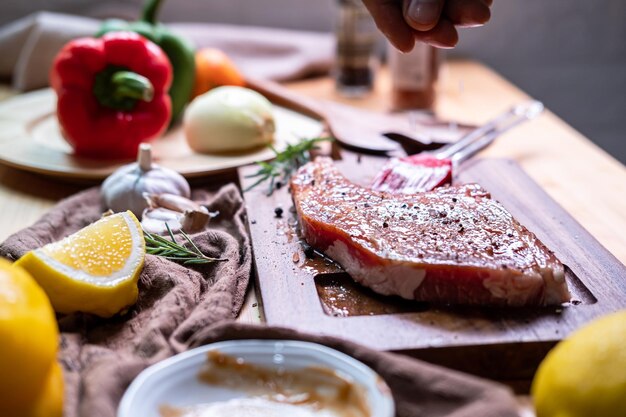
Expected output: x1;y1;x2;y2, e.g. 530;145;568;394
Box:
334;0;378;97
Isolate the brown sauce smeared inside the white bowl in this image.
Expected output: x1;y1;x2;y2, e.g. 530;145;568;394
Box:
160;351;370;417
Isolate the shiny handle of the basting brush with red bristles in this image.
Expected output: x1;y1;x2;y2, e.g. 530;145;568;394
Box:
434;100;543;159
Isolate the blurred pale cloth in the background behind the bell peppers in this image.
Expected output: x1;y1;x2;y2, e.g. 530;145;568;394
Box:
0;12;334;90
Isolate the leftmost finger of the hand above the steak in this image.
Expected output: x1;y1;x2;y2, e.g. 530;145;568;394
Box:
363;0;415;52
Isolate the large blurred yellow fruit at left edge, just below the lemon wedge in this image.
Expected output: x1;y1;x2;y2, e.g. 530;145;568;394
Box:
0;258;59;416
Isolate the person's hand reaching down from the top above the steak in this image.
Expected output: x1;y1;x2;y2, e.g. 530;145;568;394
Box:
363;0;493;52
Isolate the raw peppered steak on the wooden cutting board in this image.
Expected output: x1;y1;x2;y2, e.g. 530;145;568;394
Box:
291;158;570;306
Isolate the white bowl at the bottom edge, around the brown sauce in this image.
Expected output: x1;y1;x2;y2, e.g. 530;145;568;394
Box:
117;340;395;417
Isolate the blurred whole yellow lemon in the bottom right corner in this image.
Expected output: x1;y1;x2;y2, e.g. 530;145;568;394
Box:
531;310;626;417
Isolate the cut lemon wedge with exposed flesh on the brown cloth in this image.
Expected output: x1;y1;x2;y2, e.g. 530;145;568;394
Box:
16;211;146;317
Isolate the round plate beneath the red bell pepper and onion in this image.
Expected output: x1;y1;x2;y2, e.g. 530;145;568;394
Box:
0;89;322;180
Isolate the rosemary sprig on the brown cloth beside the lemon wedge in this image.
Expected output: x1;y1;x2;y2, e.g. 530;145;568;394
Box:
143;223;225;265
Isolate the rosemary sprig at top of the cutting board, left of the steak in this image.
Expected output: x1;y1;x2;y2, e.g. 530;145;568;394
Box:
244;137;333;196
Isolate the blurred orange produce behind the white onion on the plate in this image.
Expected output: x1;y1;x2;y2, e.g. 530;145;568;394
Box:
193;48;246;97
